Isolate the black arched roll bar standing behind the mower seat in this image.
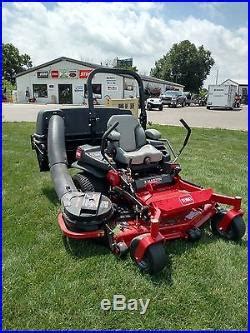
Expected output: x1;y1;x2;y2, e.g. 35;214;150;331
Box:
87;68;147;129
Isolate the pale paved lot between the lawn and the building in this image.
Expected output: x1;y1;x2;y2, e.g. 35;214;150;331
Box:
2;103;247;130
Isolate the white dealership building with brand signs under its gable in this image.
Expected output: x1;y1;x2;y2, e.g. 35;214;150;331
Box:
16;57;184;104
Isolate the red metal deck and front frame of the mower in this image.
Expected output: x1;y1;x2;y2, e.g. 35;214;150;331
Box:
58;176;243;247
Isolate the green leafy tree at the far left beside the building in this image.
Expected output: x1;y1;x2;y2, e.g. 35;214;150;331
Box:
2;43;32;84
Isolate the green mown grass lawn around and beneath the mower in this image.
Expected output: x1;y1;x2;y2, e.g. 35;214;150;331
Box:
3;123;247;329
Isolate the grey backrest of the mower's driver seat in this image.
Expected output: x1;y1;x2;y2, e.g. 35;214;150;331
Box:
107;115;146;152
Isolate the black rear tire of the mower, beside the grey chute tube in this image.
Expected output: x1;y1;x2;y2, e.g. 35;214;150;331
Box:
72;173;106;193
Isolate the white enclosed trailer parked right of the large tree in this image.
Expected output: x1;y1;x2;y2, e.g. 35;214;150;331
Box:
207;85;237;110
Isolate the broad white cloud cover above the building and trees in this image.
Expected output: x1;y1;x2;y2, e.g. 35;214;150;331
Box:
3;2;248;87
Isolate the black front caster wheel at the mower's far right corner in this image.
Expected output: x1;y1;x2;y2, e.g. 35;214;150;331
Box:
211;211;246;241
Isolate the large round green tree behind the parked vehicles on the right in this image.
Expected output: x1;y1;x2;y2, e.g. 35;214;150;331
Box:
150;40;214;93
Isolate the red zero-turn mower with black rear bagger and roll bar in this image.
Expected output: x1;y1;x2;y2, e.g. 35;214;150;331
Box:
31;68;245;274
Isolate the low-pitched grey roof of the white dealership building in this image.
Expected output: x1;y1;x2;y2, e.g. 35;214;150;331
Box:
16;57;184;87
